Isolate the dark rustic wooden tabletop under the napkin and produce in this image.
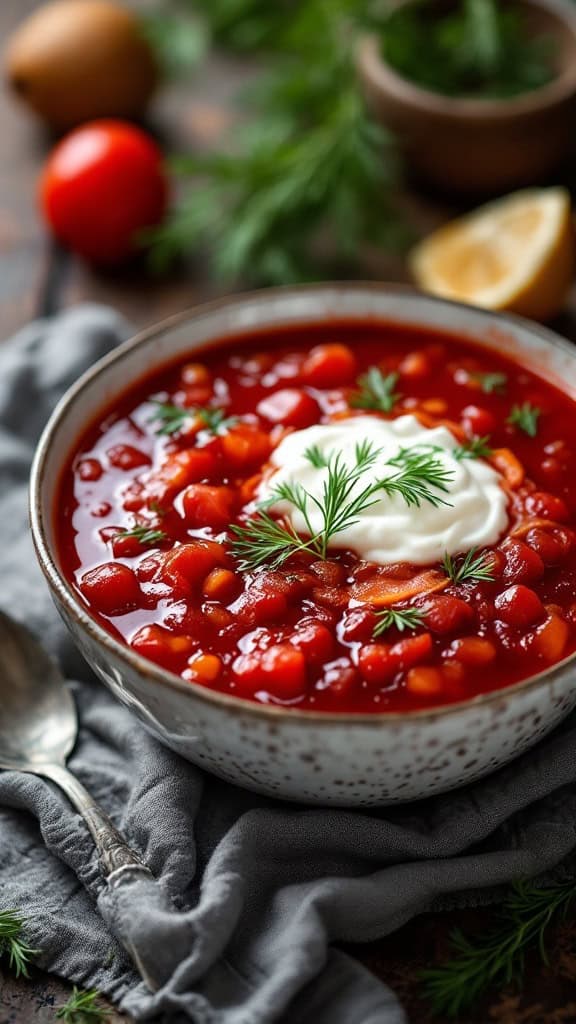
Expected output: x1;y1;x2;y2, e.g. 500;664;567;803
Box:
0;0;576;1024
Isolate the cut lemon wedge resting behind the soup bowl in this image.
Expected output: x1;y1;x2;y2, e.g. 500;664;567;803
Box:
410;188;575;321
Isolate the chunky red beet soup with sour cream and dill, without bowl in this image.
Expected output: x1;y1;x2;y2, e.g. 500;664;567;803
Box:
55;321;576;714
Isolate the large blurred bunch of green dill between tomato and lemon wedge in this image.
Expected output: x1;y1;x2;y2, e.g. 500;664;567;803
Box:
150;0;407;284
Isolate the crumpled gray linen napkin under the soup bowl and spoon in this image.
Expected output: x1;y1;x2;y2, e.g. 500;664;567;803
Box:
0;306;576;1024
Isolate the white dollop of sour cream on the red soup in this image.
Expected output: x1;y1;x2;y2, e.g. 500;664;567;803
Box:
257;416;508;565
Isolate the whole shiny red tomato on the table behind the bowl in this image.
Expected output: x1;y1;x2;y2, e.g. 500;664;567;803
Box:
40;121;168;265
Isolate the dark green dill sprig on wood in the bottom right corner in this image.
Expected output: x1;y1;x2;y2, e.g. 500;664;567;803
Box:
420;882;576;1018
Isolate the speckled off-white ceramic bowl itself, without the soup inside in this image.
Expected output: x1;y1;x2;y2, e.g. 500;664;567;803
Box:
31;284;576;805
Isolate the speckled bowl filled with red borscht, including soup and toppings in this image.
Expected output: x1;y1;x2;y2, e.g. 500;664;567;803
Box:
31;284;576;805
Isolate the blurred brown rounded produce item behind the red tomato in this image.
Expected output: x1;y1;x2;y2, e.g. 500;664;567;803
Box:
5;0;158;131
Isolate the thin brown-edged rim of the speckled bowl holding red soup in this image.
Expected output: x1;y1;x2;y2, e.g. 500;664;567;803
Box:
29;281;576;728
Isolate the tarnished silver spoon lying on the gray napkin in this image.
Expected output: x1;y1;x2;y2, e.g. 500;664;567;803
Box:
0;611;158;990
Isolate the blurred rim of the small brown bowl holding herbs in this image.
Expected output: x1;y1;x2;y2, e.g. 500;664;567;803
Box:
356;0;576;122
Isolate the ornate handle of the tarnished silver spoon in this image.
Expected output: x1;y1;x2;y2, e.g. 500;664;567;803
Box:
39;764;153;886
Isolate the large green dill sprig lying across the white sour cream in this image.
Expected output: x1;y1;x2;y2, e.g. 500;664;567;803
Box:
232;440;452;570
